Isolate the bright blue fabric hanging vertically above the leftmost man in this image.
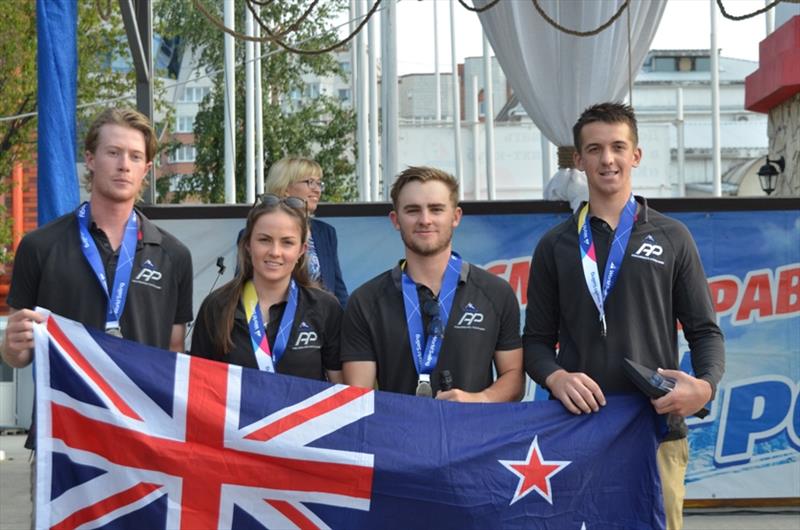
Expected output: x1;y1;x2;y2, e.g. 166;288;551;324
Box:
36;0;79;226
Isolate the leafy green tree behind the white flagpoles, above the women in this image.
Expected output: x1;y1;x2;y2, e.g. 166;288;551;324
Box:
155;0;356;202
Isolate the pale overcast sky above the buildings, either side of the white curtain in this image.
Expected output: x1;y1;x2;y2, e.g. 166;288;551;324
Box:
384;0;766;75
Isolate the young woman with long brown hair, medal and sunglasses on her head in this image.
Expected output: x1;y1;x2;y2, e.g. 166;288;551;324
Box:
190;194;342;383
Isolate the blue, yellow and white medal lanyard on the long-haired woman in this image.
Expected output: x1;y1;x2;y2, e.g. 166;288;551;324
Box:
242;278;297;373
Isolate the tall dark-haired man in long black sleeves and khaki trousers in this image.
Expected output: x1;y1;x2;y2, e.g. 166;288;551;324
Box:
523;103;725;529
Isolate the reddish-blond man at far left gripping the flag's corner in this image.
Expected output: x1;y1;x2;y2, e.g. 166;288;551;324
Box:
2;109;192;442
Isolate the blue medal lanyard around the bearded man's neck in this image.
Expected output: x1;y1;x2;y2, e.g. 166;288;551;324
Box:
403;252;461;375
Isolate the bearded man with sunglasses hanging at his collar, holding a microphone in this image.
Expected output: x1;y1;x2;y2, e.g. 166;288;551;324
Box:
341;167;523;402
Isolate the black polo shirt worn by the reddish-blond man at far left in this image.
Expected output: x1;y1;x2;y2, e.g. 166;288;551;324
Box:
8;206;192;349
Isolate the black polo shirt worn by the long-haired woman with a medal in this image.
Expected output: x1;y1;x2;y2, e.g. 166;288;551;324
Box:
190;286;343;380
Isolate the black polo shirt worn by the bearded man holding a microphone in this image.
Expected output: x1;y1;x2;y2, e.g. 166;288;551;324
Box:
341;262;522;394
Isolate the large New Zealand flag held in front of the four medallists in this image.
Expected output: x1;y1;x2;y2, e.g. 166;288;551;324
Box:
35;315;664;530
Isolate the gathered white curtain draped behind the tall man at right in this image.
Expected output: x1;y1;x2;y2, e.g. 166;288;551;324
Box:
473;0;666;205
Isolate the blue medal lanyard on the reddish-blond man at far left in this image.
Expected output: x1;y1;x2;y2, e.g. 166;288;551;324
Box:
76;202;139;330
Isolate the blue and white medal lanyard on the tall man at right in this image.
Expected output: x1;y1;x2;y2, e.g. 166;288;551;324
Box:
578;193;636;337
